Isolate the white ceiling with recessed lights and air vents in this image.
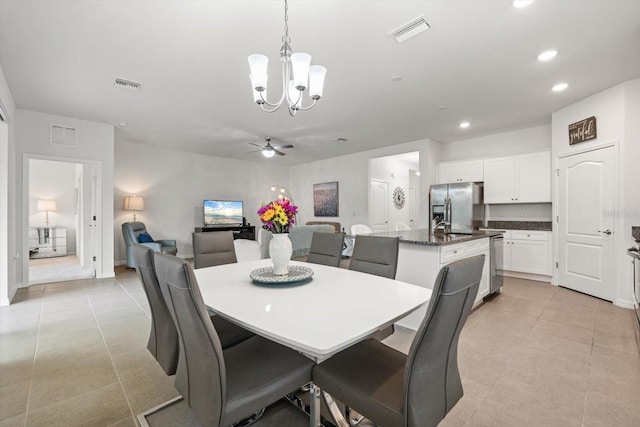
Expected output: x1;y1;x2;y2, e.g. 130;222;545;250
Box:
0;0;640;165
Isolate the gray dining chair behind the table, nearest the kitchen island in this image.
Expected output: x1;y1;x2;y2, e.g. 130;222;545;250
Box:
349;234;400;279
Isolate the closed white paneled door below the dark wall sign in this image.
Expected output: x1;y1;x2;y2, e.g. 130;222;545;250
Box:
558;147;617;301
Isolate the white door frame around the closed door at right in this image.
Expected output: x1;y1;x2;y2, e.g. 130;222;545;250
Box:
551;140;622;298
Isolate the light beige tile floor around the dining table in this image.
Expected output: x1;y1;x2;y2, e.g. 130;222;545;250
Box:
0;270;640;427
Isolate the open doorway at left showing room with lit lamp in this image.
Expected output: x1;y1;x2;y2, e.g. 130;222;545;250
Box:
23;156;99;285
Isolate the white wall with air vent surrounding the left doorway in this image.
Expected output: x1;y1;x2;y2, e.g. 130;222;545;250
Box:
13;110;114;286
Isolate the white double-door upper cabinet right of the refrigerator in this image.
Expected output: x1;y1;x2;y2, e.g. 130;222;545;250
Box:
484;151;551;203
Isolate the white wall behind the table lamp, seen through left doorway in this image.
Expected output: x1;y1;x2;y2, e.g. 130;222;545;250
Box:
29;159;76;254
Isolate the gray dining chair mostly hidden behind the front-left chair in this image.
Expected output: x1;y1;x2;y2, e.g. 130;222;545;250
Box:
132;245;255;375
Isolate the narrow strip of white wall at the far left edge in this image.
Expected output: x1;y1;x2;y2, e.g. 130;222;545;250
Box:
0;62;18;306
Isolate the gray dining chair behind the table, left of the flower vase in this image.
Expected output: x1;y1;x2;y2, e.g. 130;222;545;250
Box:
192;231;238;268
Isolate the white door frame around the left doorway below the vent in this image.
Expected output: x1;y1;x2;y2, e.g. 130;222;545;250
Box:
21;153;103;287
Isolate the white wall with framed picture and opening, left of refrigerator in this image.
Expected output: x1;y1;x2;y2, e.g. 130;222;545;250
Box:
289;139;439;231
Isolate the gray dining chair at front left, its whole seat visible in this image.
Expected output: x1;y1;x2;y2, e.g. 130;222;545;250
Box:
154;254;314;426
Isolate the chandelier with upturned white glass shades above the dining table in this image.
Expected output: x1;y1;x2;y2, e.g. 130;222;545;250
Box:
248;0;327;116
